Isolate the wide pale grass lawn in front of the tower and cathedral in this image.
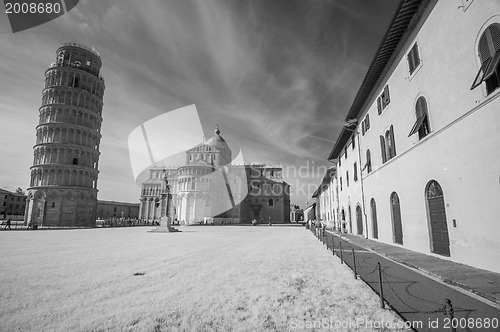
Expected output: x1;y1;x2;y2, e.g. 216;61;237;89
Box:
0;226;403;331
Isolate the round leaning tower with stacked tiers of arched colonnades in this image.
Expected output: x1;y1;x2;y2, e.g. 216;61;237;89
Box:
25;43;104;227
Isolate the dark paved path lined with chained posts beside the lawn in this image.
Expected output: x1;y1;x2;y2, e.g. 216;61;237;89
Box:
312;228;500;332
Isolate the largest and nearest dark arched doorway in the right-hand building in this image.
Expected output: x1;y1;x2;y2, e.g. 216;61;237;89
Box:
425;180;450;256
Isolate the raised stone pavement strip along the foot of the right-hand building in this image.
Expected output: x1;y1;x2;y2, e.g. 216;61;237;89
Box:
328;230;500;305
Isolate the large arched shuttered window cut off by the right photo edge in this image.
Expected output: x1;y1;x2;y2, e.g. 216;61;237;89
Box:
470;24;500;94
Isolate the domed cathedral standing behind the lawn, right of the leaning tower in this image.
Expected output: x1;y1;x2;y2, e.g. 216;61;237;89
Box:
139;127;290;225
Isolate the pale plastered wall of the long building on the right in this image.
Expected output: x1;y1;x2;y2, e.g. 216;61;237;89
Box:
354;0;500;272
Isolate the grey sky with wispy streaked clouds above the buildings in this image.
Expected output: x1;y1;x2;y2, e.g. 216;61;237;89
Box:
0;0;399;207
